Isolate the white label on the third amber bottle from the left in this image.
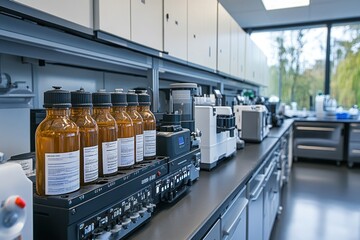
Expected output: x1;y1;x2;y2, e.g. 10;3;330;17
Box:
102;141;118;174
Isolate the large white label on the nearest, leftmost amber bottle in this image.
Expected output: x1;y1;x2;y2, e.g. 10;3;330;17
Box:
45;150;80;195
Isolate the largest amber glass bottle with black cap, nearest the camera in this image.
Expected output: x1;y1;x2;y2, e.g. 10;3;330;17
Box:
35;87;80;196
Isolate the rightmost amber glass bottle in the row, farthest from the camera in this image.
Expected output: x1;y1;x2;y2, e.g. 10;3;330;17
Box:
138;90;156;160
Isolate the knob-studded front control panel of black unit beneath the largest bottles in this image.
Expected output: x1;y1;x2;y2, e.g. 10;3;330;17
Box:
78;186;155;239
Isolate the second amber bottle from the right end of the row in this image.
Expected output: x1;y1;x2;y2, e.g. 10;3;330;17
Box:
126;90;144;163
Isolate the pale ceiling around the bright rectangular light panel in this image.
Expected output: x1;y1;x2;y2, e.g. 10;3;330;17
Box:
220;0;360;29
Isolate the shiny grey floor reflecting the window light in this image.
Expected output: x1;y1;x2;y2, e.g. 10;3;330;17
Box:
271;161;360;240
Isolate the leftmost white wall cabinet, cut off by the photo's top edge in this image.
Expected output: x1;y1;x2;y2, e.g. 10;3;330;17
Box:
14;0;93;28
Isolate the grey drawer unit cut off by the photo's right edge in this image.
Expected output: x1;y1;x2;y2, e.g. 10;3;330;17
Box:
347;123;360;167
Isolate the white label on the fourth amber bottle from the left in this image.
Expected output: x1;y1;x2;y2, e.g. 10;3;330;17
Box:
118;137;135;167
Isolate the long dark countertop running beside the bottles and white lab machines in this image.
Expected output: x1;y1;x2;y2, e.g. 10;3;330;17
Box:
130;123;293;240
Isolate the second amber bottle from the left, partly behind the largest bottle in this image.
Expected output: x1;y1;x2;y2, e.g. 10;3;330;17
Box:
70;88;99;186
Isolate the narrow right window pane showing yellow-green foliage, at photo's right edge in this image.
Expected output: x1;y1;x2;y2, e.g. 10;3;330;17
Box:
330;23;360;108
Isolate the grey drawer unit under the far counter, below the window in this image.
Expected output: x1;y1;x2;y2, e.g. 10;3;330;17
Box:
294;122;344;163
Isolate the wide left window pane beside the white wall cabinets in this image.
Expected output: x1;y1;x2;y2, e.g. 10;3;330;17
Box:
251;27;327;109
